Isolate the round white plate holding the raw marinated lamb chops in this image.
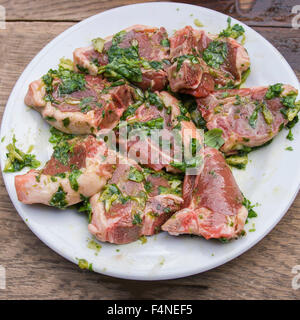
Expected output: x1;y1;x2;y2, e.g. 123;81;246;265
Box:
0;3;300;280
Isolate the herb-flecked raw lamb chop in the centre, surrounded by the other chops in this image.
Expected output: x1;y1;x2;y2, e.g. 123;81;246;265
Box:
119;91;203;172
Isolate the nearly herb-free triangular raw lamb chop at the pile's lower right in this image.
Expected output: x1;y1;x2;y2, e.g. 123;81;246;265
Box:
162;147;248;239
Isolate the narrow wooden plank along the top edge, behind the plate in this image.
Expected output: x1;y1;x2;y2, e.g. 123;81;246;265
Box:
1;0;299;27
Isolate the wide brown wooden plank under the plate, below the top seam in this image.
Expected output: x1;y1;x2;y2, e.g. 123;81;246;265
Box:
0;22;300;299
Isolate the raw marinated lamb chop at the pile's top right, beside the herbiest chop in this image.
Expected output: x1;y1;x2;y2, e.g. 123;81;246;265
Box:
167;26;250;97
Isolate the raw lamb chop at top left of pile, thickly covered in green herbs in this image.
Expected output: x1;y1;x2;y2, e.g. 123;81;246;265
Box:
73;25;169;91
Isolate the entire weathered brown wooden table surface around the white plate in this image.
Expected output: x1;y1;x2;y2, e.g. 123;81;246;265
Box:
0;0;300;299
